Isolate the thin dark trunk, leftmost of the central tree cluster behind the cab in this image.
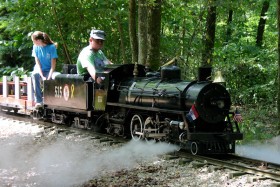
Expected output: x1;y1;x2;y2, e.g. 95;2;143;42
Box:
129;0;138;63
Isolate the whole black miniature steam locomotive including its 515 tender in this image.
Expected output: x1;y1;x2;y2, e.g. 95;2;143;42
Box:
39;64;243;154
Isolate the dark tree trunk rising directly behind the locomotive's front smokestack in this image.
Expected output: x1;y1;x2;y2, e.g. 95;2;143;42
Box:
201;0;216;66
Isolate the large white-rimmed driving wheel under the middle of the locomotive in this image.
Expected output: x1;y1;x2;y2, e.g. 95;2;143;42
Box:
130;114;143;141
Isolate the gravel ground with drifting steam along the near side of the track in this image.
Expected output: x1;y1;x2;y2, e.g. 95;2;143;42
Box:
0;114;279;187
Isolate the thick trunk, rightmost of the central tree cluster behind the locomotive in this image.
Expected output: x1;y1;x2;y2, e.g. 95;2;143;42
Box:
146;0;162;70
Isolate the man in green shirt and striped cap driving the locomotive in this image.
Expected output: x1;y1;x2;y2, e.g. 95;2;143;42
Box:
76;29;112;84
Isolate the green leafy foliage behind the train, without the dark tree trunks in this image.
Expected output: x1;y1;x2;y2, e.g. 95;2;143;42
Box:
0;0;278;122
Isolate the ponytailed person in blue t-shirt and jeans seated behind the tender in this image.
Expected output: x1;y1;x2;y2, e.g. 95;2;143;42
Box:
31;31;58;108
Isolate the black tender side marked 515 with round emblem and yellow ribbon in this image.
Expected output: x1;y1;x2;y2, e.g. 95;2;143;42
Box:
44;74;94;111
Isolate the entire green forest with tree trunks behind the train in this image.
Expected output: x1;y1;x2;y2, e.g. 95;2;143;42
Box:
0;0;280;141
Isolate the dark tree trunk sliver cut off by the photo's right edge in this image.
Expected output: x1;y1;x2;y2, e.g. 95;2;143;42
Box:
277;0;280;135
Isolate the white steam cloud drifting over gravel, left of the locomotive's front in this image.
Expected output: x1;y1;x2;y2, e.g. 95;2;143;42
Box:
0;120;178;187
